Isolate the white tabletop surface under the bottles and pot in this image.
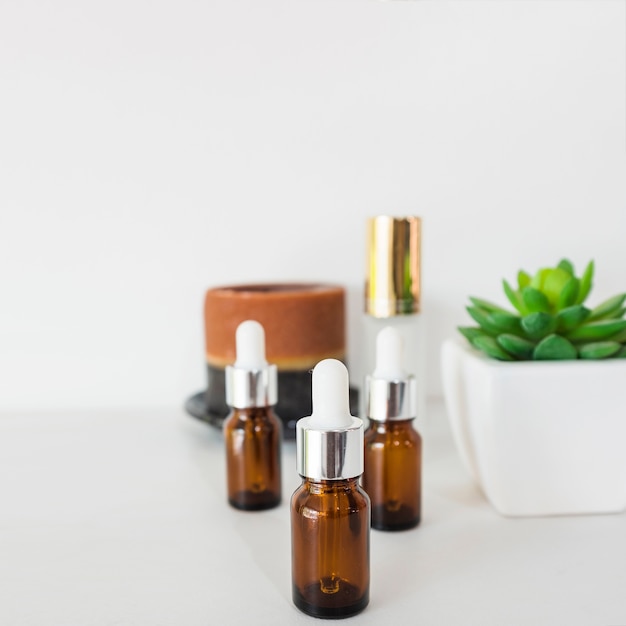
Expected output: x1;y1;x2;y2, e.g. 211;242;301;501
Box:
0;403;626;626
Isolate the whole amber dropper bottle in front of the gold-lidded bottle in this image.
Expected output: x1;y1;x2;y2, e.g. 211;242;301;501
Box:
362;326;422;530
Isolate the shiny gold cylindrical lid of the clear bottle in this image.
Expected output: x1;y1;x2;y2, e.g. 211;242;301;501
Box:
365;215;422;317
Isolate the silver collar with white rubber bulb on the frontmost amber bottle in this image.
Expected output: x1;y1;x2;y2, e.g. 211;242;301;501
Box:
296;359;363;480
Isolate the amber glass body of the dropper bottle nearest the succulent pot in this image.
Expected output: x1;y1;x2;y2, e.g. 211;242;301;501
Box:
363;419;422;530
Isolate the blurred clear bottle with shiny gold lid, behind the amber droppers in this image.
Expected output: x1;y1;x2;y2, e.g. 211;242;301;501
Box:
359;215;426;428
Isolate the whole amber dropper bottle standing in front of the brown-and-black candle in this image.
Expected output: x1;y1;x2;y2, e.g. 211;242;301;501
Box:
223;320;282;511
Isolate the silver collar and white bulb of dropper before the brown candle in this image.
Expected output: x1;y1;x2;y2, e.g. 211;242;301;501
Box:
225;320;278;409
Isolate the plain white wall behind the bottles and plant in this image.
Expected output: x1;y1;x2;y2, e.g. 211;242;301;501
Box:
0;0;626;410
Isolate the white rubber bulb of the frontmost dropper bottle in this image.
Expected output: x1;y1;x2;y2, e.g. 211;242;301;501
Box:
309;359;352;430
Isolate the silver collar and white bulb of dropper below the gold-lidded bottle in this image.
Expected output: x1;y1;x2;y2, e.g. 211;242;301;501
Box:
365;326;417;422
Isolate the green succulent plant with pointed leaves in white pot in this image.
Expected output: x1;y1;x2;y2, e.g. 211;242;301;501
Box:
458;259;626;361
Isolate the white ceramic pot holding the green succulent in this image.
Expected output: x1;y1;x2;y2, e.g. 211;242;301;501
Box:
442;340;626;516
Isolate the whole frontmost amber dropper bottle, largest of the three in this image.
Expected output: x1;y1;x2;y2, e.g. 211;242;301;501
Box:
291;359;370;618
